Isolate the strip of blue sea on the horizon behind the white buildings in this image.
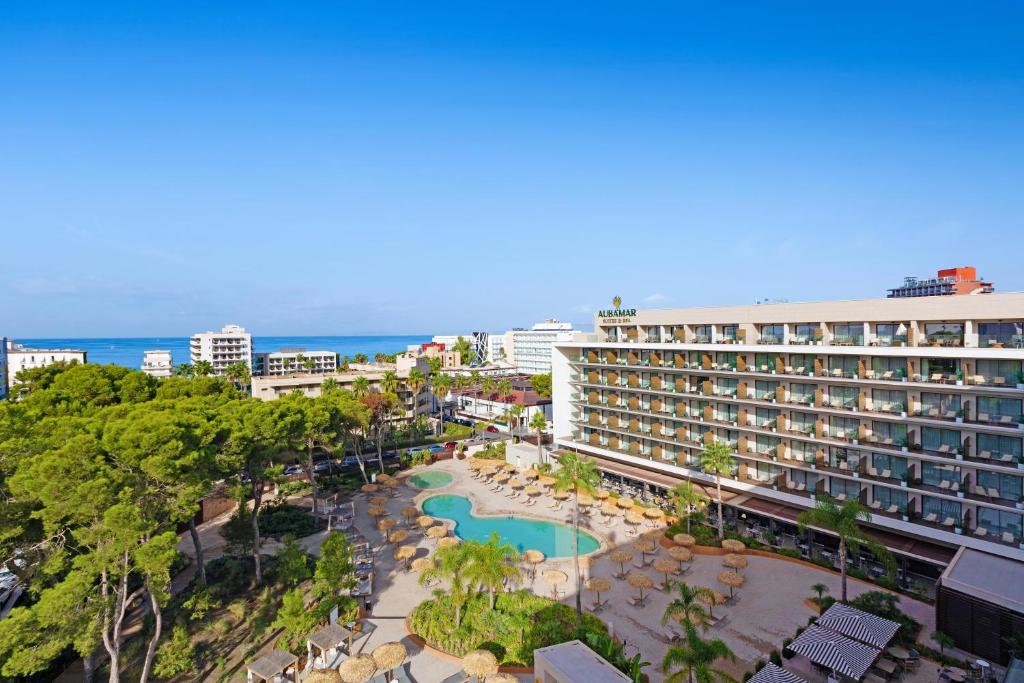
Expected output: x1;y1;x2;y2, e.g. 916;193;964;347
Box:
15;335;430;370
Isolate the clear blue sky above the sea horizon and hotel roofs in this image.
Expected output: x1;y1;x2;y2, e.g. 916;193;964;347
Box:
0;0;1024;337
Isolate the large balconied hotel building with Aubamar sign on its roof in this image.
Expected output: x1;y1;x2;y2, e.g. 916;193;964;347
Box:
553;293;1024;579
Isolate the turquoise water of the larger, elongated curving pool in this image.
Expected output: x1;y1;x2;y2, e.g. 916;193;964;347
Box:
423;494;601;557
